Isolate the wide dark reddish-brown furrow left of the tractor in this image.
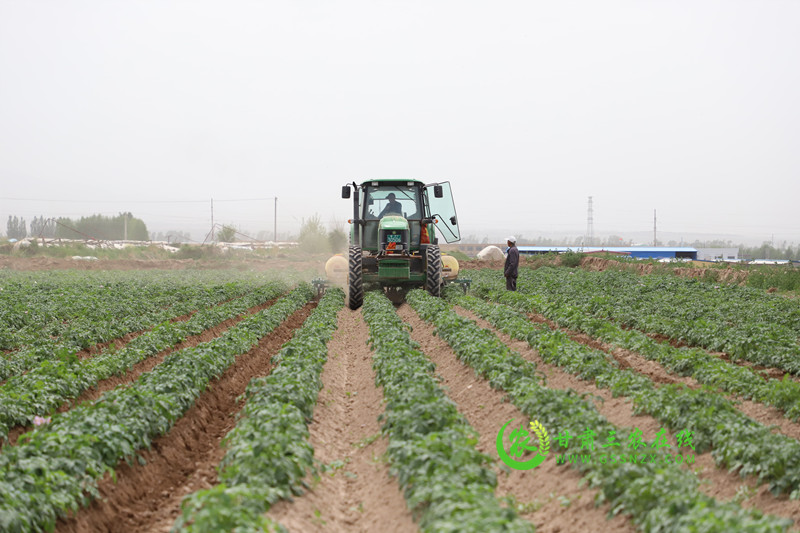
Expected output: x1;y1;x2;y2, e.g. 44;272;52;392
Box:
56;303;315;533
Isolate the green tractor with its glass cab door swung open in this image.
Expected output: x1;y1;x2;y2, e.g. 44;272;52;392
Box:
342;179;461;309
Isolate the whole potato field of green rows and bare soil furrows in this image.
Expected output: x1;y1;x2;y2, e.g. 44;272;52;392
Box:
0;267;800;532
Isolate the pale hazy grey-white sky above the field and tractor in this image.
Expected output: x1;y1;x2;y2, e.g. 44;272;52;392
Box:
0;0;800;244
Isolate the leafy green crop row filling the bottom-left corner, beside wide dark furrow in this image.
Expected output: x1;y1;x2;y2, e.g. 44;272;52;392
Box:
0;284;313;532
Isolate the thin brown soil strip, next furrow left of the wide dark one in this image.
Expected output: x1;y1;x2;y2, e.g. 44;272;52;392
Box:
7;298;277;445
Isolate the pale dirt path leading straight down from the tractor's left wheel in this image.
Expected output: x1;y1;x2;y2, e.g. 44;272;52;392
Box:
268;308;418;533
